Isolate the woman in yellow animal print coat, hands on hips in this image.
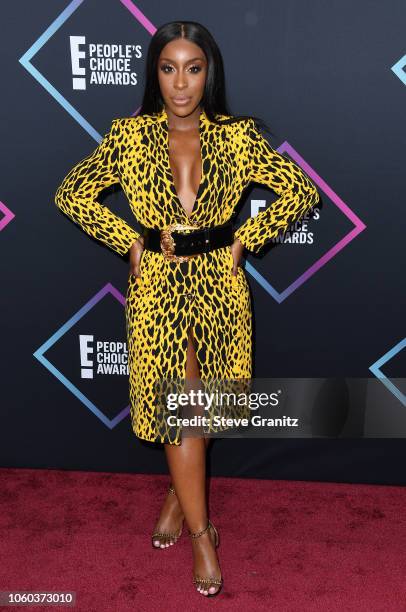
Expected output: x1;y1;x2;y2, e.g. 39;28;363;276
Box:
56;22;319;595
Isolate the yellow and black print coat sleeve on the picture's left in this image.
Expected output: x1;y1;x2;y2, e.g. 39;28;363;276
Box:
55;119;140;255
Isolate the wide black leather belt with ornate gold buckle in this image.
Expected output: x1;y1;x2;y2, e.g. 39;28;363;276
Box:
143;221;234;261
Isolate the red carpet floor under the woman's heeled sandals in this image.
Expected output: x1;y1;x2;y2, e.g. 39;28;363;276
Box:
0;469;406;612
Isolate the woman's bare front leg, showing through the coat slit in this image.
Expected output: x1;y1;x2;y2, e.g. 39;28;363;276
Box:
165;333;220;595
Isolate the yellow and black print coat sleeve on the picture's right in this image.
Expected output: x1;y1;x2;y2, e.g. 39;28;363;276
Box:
234;119;320;253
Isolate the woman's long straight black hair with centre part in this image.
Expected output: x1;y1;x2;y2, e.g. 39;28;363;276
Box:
137;21;272;134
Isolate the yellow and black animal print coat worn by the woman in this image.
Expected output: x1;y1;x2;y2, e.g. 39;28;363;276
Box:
55;107;319;445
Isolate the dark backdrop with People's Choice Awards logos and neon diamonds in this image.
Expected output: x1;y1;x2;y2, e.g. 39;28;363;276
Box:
0;0;406;483
